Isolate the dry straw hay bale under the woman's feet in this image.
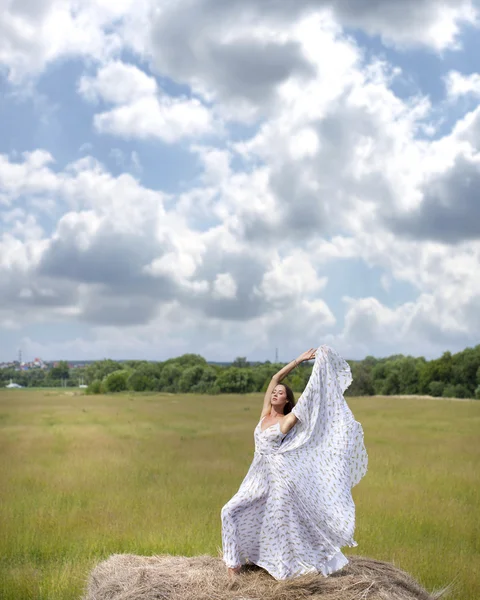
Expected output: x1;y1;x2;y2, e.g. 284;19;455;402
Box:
83;554;450;600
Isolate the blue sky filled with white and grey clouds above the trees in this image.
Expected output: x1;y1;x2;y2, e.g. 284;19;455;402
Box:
0;0;480;362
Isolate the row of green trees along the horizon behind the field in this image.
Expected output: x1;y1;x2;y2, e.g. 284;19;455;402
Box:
0;345;480;399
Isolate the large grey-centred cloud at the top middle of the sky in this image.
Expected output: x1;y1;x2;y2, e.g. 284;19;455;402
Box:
150;8;311;119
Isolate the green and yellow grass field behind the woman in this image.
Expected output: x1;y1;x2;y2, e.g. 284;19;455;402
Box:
0;390;480;600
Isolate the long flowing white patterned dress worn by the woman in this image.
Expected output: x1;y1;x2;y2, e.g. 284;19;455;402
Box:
221;345;368;580
